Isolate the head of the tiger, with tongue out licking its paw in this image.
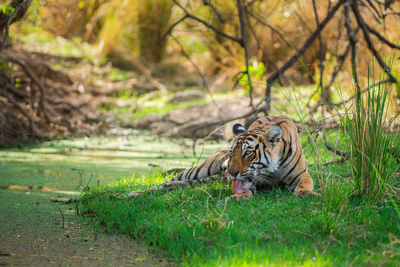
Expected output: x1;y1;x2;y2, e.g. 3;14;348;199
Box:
227;124;284;194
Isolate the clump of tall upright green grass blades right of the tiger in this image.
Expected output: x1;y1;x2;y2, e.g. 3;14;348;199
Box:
344;72;399;202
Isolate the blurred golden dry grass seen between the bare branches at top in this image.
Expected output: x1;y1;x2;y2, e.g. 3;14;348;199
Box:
25;0;400;87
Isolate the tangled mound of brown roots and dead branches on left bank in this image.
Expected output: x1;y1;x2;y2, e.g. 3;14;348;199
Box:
0;46;105;146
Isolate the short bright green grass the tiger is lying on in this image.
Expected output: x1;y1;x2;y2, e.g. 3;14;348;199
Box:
80;135;400;266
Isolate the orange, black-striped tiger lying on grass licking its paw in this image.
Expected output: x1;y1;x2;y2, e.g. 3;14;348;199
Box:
128;116;319;200
